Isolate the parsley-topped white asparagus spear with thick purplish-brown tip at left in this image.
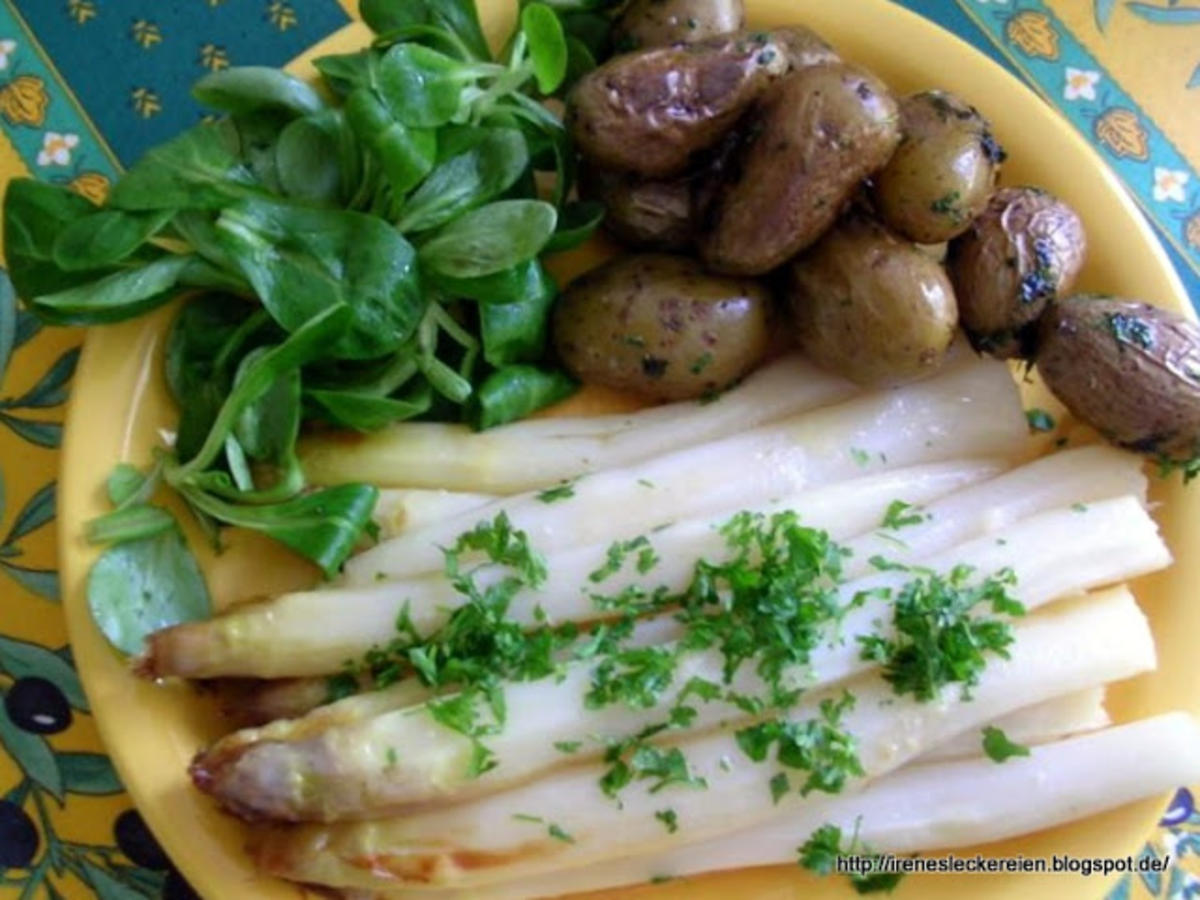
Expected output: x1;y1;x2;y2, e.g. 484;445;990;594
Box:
193;497;1170;821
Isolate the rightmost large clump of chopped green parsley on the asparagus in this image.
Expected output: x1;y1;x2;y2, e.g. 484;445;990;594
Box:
858;565;1025;701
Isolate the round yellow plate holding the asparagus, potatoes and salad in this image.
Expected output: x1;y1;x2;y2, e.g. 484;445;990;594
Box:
60;0;1200;900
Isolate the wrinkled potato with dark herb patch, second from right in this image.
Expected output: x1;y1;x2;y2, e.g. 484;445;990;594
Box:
946;187;1087;359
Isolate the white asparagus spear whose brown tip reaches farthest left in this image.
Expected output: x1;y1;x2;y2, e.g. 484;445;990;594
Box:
144;460;1003;678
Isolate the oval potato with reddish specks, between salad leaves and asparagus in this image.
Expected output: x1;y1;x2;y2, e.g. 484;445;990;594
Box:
552;253;770;401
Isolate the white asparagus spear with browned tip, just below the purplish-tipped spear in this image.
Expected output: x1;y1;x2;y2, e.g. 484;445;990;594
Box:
254;590;1154;888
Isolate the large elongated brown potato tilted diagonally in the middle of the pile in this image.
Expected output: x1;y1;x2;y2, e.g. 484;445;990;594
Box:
701;64;900;275
